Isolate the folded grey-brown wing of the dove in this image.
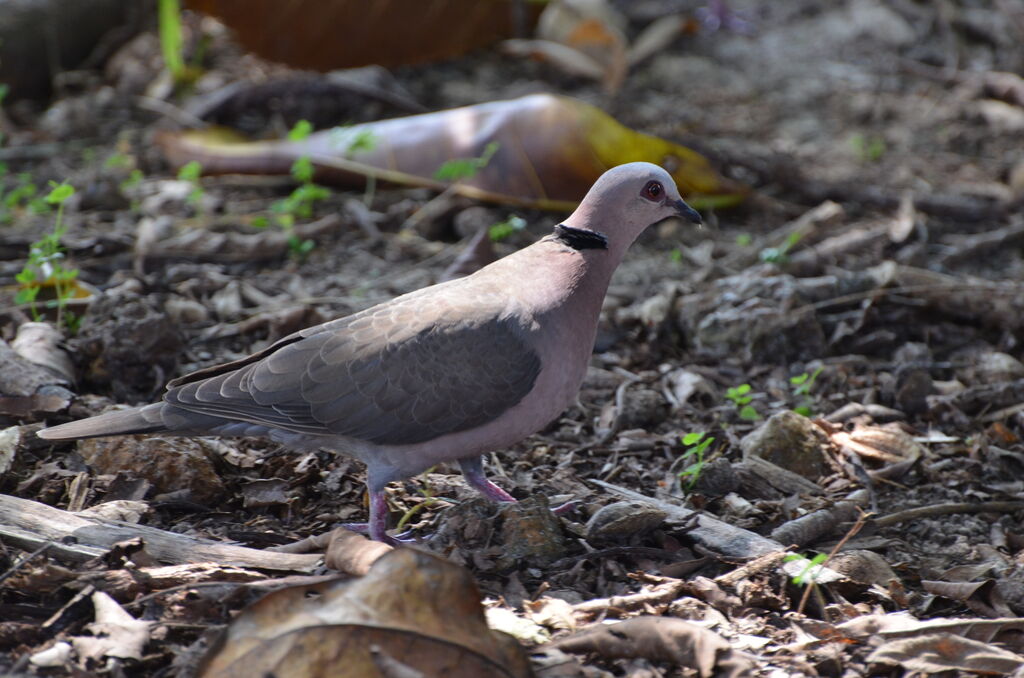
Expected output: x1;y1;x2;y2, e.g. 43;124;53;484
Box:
164;295;541;444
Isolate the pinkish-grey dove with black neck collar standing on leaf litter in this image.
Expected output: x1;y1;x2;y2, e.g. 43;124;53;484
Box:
38;163;700;544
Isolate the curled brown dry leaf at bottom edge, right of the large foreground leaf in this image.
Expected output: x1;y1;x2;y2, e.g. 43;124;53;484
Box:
547;617;755;678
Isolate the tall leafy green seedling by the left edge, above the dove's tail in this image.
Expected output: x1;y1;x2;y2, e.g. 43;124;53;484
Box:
14;181;79;331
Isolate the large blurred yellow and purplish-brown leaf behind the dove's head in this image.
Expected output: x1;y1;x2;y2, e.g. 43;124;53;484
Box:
157;94;744;210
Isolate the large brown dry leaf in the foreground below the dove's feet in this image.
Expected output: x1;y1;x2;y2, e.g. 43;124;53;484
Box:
199;548;531;678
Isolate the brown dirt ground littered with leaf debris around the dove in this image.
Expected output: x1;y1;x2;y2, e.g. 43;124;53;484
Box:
0;0;1024;678
